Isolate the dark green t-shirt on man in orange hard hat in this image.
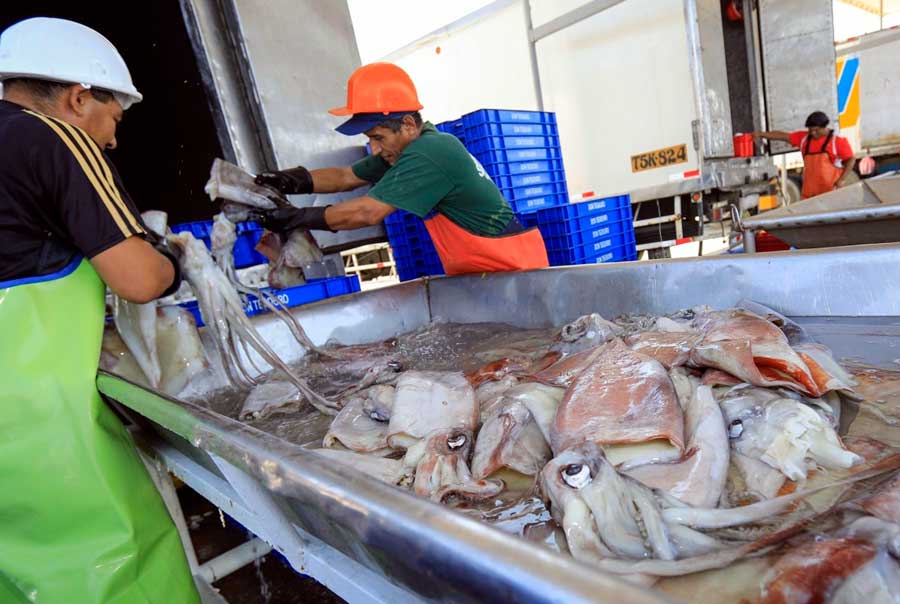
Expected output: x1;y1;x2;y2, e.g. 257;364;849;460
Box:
352;122;513;235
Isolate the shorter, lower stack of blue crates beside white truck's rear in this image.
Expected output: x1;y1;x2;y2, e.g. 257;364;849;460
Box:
519;195;637;266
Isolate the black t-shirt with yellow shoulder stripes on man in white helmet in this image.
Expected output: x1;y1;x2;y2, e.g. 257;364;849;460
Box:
0;100;147;284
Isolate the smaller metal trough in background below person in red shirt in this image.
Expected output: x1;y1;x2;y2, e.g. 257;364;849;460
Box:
735;174;900;252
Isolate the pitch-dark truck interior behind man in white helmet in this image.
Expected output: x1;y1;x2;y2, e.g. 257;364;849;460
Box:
0;0;222;224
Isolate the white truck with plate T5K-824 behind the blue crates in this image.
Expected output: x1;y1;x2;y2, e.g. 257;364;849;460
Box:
376;0;837;256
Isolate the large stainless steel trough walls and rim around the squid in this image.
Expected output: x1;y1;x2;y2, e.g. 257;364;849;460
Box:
98;245;900;604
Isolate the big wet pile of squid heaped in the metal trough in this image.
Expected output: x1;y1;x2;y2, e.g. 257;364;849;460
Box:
302;302;900;602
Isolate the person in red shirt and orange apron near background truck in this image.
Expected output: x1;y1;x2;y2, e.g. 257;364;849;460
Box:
752;111;856;199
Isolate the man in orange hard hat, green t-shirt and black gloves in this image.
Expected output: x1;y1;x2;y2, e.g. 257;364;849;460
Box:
256;63;549;275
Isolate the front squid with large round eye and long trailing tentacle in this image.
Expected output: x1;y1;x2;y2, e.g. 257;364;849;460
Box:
540;442;900;581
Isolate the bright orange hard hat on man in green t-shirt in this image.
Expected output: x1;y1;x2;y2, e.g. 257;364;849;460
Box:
328;63;422;115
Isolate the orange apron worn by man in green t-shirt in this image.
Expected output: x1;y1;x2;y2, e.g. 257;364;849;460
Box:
425;214;550;275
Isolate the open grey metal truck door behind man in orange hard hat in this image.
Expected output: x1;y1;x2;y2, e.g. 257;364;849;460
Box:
182;0;384;250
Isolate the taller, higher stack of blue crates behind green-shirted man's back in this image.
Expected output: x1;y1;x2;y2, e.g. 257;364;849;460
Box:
462;109;567;214
